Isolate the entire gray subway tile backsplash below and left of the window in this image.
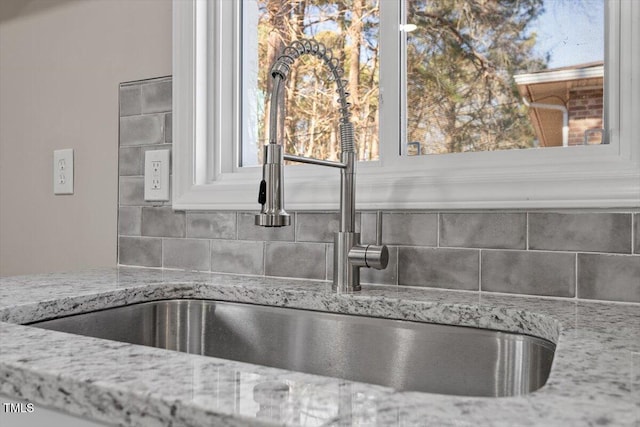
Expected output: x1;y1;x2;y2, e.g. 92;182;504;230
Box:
118;78;640;302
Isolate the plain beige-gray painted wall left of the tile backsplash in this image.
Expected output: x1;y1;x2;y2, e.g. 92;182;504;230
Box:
0;0;172;276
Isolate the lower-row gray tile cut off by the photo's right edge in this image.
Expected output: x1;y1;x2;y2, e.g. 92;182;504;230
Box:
578;254;640;302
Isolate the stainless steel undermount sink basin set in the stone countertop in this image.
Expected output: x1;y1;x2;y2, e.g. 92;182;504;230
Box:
31;300;555;397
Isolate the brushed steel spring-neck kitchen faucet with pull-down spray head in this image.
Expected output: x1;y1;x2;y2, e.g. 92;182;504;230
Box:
255;39;389;293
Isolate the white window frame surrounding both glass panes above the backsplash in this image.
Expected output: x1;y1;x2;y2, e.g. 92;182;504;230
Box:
172;0;640;211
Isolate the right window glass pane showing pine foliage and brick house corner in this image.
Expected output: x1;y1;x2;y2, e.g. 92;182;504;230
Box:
405;0;604;155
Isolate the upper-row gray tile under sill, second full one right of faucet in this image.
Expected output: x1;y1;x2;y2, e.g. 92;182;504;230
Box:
440;212;527;249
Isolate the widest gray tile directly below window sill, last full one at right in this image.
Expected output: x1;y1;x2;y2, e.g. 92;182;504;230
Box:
529;212;631;253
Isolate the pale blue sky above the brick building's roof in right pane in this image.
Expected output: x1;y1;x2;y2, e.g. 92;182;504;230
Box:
531;0;605;68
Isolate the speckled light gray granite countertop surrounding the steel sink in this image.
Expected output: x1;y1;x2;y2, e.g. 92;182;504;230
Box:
0;268;640;426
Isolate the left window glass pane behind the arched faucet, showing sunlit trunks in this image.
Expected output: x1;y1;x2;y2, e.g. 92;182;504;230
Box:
241;0;379;166
